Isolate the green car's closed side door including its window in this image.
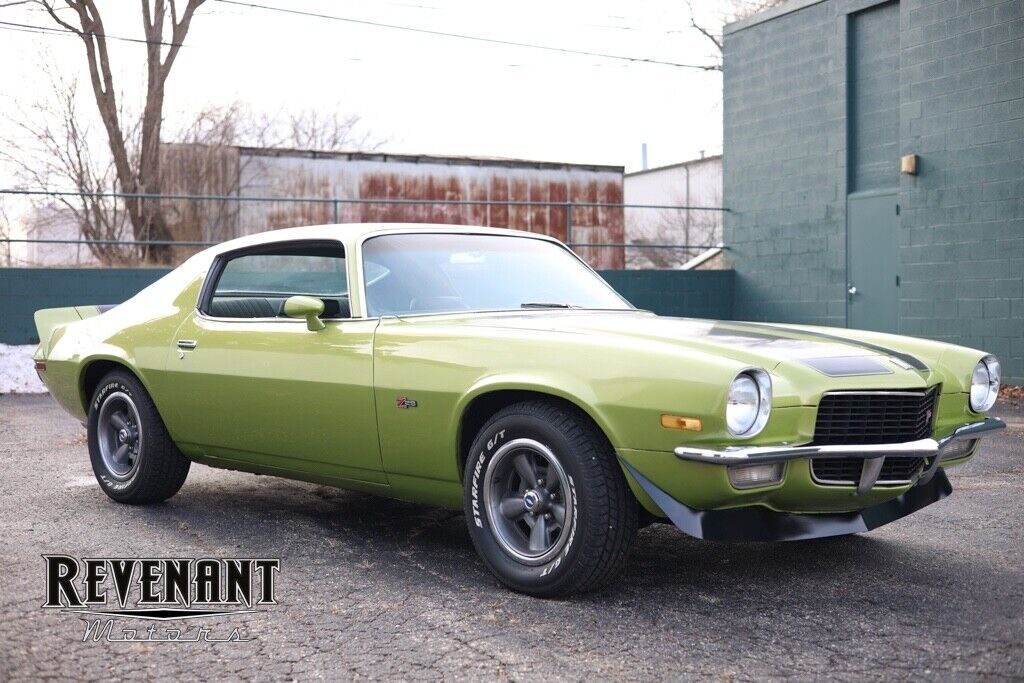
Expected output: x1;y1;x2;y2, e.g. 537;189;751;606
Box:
161;241;386;483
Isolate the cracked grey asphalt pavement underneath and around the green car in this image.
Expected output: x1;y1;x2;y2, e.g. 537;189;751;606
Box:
0;395;1024;681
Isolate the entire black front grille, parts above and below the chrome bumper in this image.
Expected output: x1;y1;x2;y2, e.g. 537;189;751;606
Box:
811;387;939;485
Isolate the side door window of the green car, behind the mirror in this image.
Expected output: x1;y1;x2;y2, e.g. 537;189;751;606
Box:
201;242;351;319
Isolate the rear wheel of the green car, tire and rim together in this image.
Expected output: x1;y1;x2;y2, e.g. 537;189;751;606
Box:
87;371;191;505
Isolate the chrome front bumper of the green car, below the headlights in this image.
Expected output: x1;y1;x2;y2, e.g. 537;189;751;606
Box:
675;418;1007;496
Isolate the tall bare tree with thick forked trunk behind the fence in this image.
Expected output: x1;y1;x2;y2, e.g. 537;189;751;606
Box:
38;0;205;263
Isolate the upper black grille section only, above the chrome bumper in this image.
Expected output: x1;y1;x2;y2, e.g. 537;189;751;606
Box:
814;387;939;445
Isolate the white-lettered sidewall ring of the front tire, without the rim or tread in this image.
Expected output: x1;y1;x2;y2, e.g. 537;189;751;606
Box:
464;415;592;593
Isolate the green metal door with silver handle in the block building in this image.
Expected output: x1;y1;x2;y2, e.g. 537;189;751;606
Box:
847;191;899;332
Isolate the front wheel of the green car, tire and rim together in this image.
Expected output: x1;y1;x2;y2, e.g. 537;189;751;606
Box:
464;401;637;597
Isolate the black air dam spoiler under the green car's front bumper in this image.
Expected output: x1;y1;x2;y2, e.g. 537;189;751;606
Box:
621;460;953;542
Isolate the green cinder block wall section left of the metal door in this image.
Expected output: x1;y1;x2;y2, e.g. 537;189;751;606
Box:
723;2;846;326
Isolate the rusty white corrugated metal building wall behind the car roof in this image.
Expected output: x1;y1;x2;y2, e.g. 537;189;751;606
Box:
238;148;625;268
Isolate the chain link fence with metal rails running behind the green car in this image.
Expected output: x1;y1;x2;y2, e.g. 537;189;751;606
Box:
0;189;727;269
